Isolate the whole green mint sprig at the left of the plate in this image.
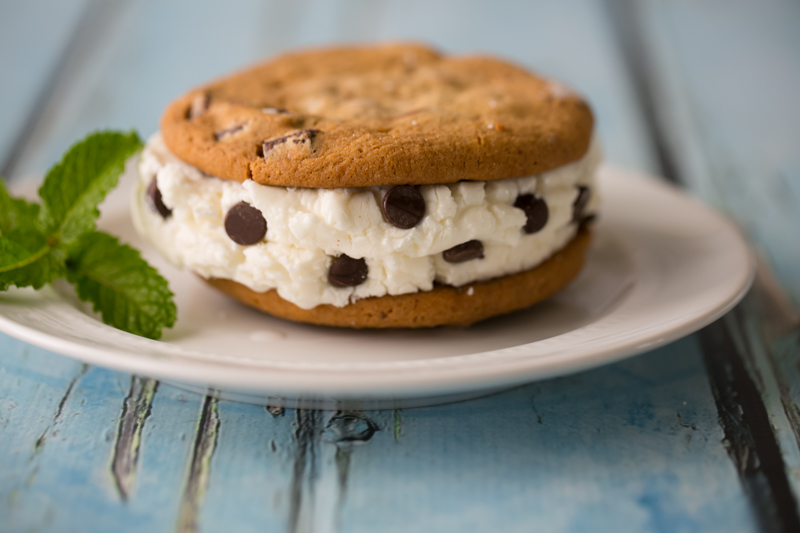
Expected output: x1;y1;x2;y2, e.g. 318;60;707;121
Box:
0;131;177;339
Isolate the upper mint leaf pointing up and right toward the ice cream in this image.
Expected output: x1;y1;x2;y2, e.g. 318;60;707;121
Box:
39;131;142;244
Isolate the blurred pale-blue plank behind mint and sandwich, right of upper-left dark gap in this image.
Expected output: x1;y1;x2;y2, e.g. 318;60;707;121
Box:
10;0;314;179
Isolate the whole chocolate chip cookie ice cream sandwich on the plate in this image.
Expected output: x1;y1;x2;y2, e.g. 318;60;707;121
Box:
132;44;600;328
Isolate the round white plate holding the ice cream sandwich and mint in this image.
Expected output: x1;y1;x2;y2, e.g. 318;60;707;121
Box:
0;167;754;409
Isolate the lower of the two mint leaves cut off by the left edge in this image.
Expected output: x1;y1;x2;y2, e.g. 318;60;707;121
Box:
0;228;63;290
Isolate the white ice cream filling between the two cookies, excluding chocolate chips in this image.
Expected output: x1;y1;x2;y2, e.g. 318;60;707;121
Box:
133;134;600;309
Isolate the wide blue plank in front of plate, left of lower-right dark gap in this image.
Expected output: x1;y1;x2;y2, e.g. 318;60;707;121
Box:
341;338;754;531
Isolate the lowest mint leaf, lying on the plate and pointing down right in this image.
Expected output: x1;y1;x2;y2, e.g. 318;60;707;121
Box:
67;232;177;339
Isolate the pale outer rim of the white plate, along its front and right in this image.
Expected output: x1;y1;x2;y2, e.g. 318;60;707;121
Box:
0;163;756;398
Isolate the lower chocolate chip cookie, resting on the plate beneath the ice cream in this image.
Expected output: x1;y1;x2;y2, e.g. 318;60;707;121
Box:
205;226;591;328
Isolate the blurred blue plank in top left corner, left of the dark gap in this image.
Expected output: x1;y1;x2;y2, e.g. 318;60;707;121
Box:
0;0;88;177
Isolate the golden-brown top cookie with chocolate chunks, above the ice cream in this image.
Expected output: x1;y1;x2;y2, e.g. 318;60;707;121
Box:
161;44;593;188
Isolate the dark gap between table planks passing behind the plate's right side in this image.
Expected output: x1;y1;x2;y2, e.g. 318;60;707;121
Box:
605;0;800;532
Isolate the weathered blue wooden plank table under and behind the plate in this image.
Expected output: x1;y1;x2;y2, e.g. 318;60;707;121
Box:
0;0;800;532
